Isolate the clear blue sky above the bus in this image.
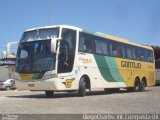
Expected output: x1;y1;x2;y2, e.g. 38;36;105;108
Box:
0;0;160;52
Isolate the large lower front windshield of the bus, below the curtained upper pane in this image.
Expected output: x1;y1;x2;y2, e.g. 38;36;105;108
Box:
16;40;56;73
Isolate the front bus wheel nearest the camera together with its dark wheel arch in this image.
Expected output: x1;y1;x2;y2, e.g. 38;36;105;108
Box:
78;75;91;97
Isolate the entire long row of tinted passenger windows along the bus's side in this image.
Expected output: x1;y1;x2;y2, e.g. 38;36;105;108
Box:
79;33;153;62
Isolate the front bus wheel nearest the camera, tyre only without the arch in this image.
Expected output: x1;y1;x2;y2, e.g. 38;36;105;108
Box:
78;77;86;97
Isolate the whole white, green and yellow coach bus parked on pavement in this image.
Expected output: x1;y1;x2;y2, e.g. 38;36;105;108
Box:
15;25;155;96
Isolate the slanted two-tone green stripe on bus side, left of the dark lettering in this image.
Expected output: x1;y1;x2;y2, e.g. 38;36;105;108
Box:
94;55;124;82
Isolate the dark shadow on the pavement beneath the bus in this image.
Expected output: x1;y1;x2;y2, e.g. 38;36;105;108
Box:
7;90;151;99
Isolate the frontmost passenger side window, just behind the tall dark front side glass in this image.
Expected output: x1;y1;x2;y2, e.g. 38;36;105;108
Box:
79;33;94;53
